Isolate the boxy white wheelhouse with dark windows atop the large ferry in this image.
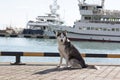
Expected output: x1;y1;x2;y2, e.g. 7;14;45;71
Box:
78;3;103;21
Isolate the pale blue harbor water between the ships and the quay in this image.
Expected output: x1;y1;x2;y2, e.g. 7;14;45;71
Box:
0;37;120;64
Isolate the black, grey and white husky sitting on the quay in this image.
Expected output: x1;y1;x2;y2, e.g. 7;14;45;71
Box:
55;31;97;69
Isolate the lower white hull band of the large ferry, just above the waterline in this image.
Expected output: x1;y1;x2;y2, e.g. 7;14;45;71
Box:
68;33;120;42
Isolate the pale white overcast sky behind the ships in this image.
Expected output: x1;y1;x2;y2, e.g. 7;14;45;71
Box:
0;0;120;29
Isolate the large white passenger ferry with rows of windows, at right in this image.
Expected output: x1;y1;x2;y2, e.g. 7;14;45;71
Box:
64;0;120;42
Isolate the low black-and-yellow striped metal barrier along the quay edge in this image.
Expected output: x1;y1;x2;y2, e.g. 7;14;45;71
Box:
0;51;120;65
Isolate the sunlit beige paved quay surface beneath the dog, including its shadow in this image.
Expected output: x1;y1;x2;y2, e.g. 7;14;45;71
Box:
0;63;120;80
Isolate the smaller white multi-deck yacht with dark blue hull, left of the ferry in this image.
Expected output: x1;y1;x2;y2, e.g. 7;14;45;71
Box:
23;0;64;38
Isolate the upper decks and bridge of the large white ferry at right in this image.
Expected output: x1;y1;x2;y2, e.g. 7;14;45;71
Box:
78;0;120;23
